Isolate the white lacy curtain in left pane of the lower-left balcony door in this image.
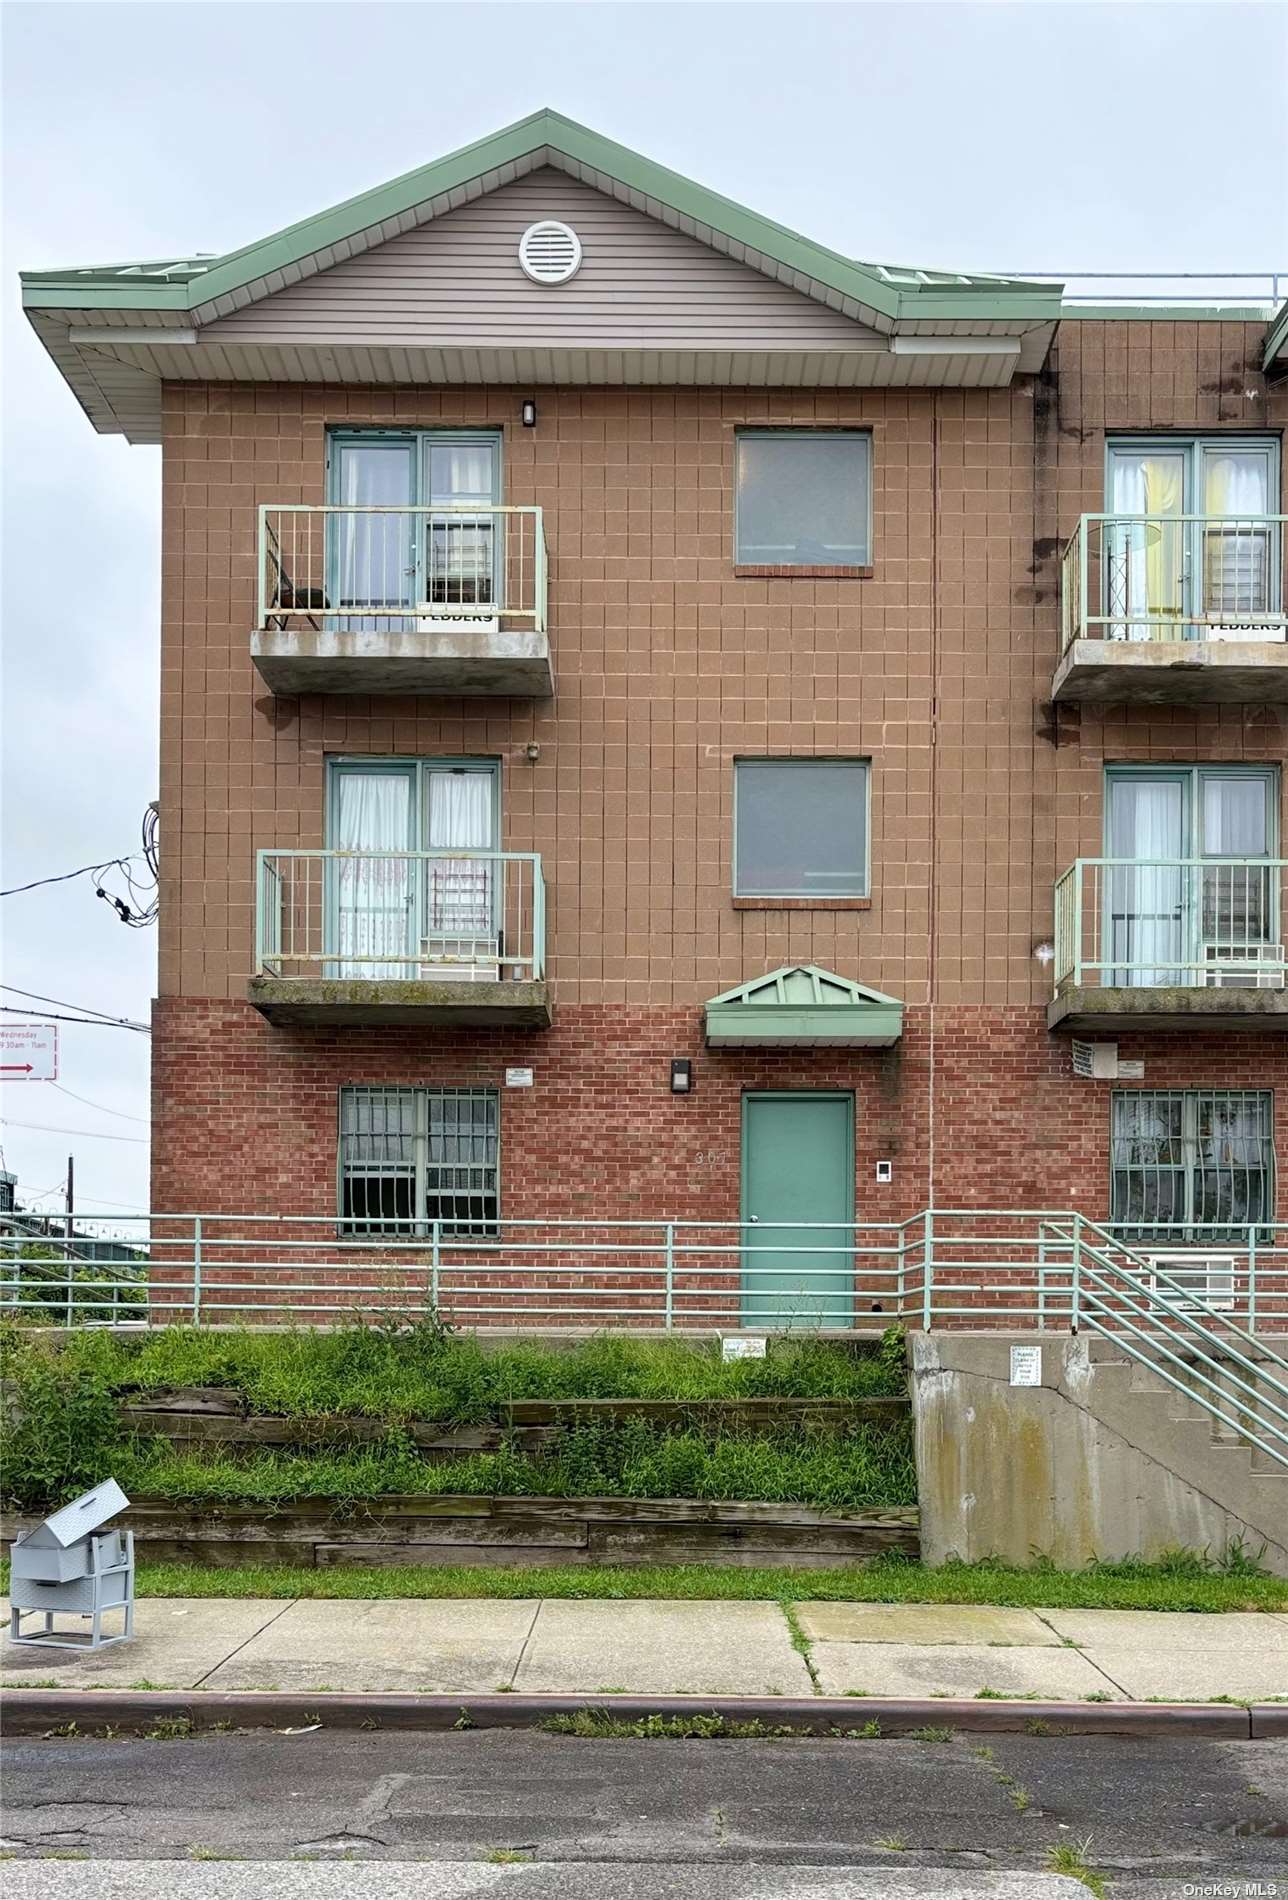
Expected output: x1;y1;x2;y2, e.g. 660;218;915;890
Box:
332;771;416;979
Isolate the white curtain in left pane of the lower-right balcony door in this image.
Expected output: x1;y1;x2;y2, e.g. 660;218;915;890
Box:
1102;777;1191;988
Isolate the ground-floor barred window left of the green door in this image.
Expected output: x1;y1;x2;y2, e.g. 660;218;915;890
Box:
340;1089;500;1239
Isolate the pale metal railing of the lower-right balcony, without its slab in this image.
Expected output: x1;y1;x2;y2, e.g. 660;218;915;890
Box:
1054;857;1288;996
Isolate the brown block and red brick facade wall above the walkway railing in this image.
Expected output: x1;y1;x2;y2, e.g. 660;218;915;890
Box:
154;321;1288;1212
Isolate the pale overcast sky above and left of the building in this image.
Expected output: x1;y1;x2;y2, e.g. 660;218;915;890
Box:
0;0;1288;1212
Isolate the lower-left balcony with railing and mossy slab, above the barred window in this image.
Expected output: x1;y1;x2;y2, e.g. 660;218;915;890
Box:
247;851;551;1030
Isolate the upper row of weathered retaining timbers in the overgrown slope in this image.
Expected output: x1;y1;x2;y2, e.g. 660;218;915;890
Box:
120;1387;910;1461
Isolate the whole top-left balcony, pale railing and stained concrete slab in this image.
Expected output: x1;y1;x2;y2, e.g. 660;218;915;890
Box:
251;504;555;699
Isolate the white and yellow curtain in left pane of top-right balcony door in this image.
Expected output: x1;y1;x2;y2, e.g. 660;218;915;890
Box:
1104;452;1185;640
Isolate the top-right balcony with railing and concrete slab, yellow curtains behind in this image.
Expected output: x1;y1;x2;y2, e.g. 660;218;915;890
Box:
1051;515;1288;707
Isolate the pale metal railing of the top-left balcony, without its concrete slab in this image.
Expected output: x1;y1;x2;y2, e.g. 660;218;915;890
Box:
256;504;547;633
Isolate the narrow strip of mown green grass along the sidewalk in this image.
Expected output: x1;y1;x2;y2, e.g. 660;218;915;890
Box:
27;1556;1288;1611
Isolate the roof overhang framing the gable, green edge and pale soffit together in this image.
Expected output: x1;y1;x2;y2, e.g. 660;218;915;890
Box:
23;112;1060;441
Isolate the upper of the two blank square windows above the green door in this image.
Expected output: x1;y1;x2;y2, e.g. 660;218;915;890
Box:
733;429;872;568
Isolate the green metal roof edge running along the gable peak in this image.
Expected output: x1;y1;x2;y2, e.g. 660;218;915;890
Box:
21;108;1060;319
